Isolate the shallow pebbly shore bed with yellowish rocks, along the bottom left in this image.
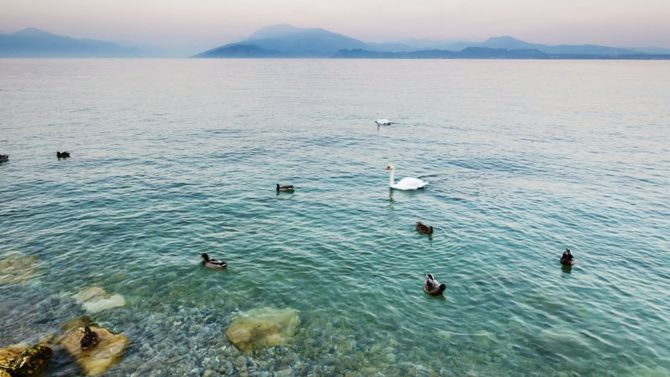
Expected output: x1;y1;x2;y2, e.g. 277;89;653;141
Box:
0;253;435;377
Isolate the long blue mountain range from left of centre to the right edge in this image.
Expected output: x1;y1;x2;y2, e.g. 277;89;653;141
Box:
195;24;670;59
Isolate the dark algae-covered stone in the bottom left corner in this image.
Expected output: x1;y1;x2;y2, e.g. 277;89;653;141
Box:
0;344;53;377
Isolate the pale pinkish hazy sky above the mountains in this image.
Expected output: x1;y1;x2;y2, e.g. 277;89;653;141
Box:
0;0;670;54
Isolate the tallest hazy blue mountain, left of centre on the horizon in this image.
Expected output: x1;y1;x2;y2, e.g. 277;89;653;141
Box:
196;25;367;58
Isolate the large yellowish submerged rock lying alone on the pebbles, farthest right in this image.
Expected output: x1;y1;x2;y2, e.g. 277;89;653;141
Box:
225;308;300;352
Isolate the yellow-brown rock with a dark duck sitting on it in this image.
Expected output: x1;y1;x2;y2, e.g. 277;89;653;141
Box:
61;326;128;376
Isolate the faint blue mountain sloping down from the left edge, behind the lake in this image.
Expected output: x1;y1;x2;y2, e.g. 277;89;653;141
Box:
0;28;142;57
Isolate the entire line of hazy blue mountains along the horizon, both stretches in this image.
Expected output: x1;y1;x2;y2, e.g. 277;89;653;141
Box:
0;24;670;59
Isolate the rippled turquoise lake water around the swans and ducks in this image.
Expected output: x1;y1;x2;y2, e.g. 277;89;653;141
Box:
0;60;670;376
